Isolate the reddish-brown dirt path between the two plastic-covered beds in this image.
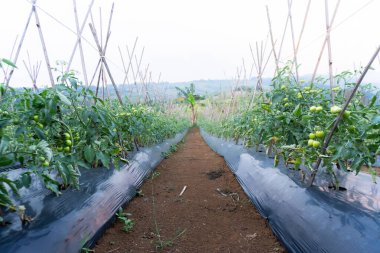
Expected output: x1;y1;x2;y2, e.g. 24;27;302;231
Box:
94;128;284;253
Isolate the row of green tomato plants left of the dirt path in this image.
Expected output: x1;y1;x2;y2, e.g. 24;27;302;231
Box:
0;70;190;217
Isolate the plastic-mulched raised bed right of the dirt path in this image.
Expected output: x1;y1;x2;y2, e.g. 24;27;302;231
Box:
202;131;380;253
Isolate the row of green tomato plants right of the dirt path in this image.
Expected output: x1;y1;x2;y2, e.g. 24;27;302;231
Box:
200;66;380;183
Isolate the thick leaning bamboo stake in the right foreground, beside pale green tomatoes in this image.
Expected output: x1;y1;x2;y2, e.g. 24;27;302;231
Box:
309;46;380;186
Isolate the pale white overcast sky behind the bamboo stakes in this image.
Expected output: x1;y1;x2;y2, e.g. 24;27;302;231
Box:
0;0;380;86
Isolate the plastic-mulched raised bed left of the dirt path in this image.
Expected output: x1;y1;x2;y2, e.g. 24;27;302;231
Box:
0;130;185;253
